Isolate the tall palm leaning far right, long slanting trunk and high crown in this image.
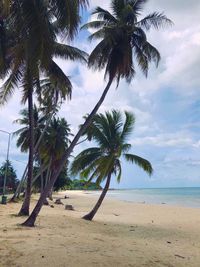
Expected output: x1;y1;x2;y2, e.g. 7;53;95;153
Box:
23;0;172;226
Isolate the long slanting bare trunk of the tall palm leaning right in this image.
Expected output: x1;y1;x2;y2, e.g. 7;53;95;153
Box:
22;80;112;227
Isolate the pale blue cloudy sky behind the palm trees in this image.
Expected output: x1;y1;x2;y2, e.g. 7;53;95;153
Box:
0;0;200;188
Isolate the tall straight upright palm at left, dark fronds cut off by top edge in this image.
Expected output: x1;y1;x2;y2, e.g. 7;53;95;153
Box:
0;0;87;215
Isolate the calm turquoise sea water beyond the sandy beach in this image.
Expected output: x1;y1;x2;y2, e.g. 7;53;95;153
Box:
88;187;200;208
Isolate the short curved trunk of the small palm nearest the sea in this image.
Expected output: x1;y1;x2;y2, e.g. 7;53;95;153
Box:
83;173;111;221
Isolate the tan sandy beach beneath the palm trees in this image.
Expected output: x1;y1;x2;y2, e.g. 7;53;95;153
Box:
0;191;200;267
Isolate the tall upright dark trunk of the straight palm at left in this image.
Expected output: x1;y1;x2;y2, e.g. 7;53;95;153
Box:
19;84;34;216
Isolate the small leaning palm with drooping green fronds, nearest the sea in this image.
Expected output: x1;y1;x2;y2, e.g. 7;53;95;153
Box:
71;110;153;221
